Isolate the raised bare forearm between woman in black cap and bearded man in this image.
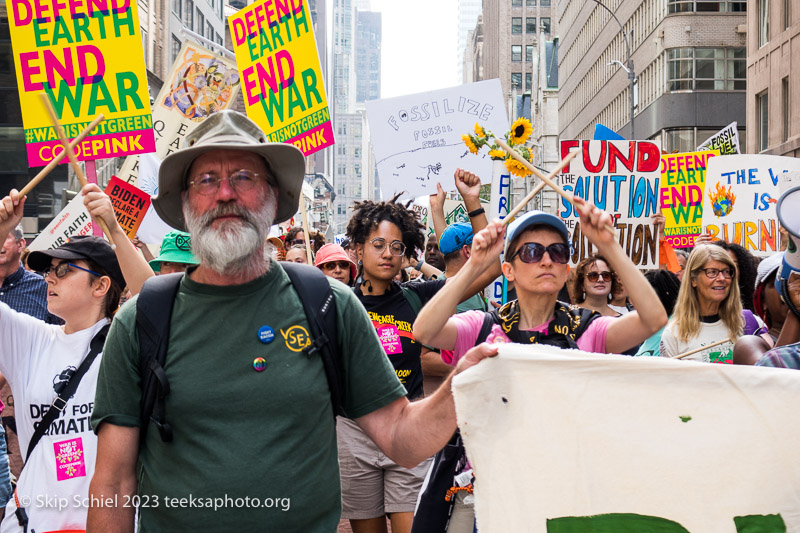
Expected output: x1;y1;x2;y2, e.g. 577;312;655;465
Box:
81;183;155;290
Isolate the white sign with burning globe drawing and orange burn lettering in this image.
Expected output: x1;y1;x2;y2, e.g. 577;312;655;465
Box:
703;154;800;257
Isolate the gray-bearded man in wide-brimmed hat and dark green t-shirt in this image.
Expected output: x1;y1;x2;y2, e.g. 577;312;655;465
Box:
87;110;496;533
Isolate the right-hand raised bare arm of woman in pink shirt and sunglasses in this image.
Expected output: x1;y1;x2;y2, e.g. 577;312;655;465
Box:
575;196;667;353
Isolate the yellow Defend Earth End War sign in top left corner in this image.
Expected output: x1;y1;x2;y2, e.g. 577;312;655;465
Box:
6;0;155;167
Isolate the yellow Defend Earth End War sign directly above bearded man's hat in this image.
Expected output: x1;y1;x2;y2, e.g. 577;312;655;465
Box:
228;0;334;155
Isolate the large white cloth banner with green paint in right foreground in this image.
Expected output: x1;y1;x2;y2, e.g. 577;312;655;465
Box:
453;344;800;533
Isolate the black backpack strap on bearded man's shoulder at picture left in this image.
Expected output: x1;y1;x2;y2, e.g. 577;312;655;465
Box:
136;273;183;442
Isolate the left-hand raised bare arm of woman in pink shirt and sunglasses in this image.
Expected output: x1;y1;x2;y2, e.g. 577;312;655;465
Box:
414;220;505;350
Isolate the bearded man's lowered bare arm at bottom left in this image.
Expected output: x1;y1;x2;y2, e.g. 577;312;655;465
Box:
86;422;139;533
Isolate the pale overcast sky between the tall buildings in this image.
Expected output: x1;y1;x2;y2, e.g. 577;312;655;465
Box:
370;0;460;98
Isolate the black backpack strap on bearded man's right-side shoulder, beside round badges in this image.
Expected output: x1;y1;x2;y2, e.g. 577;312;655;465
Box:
281;262;345;417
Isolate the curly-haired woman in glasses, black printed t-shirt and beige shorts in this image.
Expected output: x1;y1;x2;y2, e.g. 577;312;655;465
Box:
337;186;500;533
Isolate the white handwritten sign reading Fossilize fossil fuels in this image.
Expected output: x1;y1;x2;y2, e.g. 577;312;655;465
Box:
366;79;508;199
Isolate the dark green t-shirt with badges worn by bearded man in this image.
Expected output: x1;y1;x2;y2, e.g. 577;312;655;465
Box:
92;262;405;532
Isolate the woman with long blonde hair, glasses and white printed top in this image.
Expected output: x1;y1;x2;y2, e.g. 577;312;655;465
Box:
660;244;766;363
